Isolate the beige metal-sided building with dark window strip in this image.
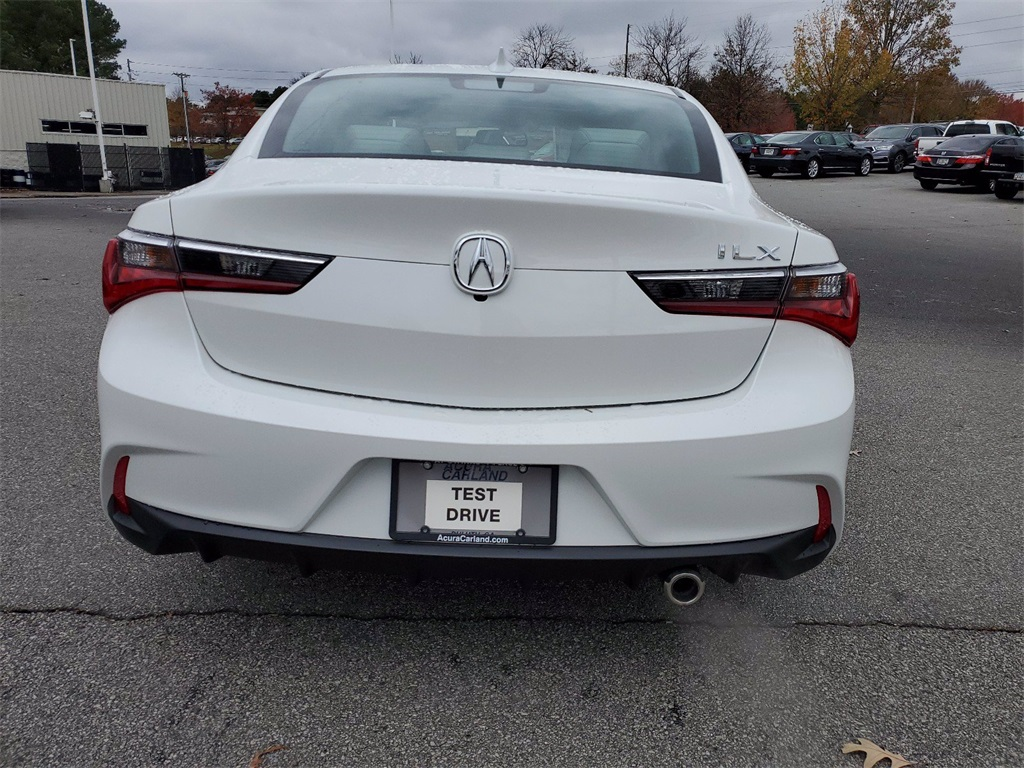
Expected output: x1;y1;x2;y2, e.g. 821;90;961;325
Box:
0;70;170;170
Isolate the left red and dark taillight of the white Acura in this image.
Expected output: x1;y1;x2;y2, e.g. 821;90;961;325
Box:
103;229;331;312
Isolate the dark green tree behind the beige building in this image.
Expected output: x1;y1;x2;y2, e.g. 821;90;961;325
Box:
0;0;125;79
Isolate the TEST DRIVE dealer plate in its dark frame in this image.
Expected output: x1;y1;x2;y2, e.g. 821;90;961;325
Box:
388;459;558;547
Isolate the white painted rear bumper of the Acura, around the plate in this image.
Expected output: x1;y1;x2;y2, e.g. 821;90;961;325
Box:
98;294;854;558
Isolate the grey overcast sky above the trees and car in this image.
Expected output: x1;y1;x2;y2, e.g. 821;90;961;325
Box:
104;0;1024;97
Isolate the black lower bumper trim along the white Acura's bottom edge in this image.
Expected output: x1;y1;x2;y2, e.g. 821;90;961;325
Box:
108;500;837;582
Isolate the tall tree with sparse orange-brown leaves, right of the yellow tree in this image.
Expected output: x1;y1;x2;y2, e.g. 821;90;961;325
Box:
844;0;961;122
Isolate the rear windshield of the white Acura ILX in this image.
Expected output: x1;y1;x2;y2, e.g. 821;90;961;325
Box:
260;74;722;181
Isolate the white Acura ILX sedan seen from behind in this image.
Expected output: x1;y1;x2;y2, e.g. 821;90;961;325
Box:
98;57;859;604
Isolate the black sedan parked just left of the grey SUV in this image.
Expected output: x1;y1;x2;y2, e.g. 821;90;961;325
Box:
751;131;871;179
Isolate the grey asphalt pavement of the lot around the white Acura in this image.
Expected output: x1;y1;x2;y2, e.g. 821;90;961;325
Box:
0;173;1024;768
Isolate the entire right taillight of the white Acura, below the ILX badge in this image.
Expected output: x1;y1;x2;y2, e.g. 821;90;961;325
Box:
631;263;860;346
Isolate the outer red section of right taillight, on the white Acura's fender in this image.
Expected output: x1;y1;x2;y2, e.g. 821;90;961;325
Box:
778;269;860;346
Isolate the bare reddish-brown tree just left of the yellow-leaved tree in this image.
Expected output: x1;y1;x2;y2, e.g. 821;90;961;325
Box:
705;13;778;131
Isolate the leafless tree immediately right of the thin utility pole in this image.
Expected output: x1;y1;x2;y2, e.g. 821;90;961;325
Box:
630;13;705;90
